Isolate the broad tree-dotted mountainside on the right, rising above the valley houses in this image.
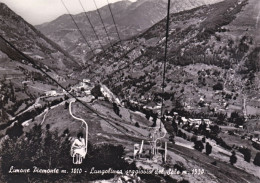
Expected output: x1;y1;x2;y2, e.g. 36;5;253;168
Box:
80;0;260;126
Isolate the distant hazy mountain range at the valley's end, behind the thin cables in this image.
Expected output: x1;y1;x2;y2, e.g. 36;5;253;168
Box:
36;0;221;62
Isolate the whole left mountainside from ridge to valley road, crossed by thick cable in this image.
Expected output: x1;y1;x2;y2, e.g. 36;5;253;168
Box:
0;3;79;123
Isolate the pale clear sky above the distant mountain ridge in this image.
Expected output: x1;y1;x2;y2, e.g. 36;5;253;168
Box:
0;0;136;25
